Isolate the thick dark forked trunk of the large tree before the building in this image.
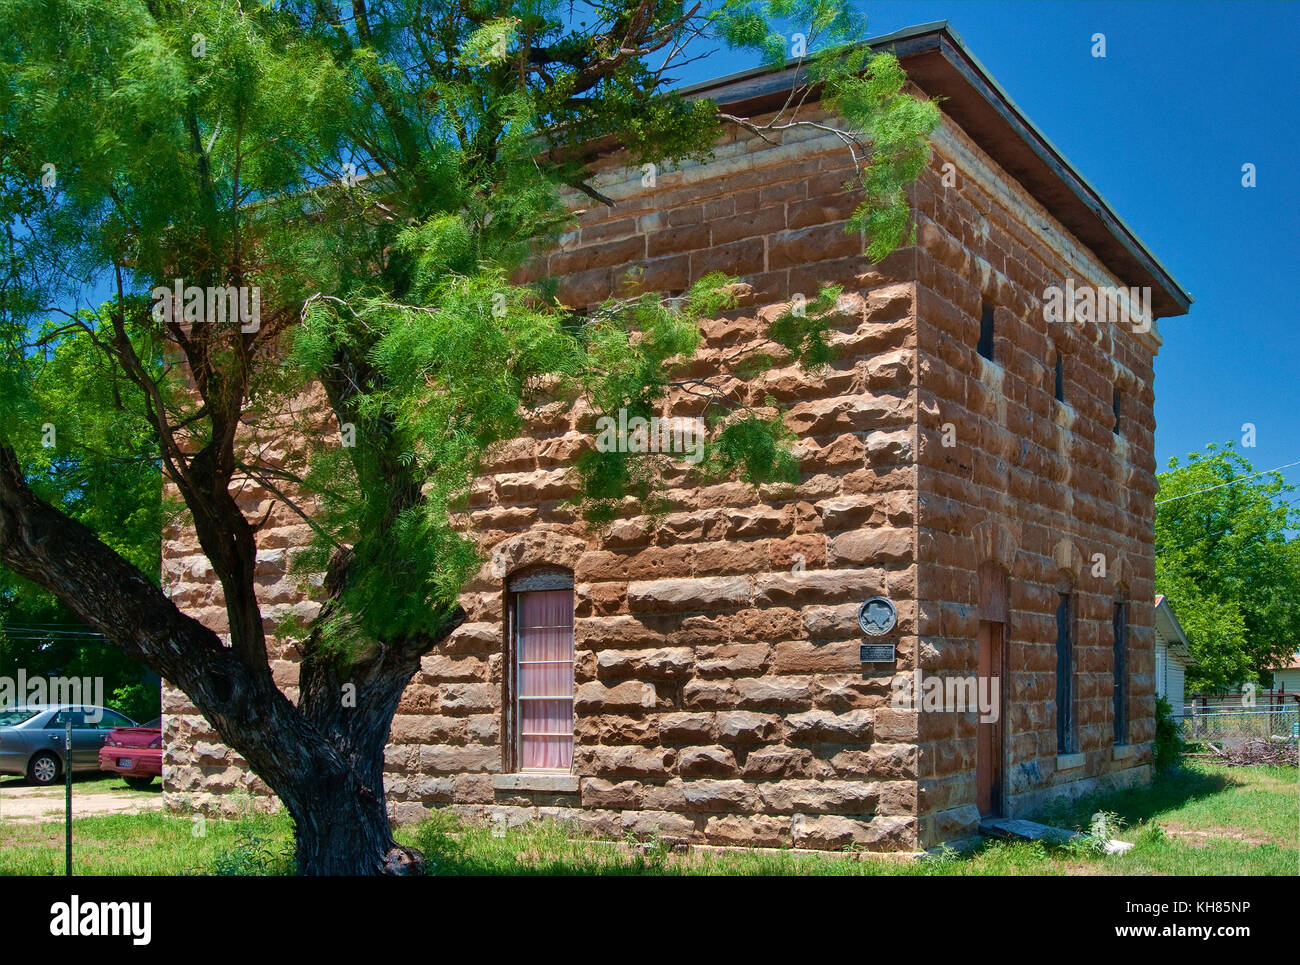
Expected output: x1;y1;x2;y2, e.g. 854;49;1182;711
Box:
0;446;441;875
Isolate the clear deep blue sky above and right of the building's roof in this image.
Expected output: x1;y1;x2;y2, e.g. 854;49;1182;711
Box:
689;0;1300;485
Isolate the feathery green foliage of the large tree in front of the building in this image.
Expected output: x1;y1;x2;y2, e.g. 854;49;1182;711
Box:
0;0;937;853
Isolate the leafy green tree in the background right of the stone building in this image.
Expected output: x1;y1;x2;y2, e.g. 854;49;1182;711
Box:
1156;443;1300;689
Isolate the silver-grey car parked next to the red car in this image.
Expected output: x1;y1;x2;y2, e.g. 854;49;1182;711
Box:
0;704;135;784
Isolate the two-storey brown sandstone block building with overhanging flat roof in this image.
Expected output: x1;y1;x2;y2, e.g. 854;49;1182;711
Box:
164;23;1191;851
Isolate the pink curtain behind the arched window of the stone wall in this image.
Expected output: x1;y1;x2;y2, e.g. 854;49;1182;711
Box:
517;589;573;770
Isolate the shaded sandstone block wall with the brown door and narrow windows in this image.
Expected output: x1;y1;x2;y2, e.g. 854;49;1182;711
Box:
915;115;1158;841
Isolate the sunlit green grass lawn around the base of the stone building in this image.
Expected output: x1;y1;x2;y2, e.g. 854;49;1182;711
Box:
0;763;1300;877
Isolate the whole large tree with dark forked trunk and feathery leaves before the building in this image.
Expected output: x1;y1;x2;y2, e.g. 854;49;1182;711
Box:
0;0;937;874
